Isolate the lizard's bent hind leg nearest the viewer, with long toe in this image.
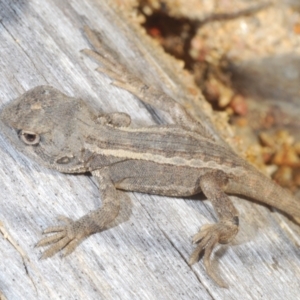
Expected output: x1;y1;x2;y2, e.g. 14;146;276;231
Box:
189;171;239;287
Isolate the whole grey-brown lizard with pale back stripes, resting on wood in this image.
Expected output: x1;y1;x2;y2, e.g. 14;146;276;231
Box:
0;27;300;287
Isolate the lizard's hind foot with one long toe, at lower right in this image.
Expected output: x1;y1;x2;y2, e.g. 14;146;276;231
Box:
189;220;238;288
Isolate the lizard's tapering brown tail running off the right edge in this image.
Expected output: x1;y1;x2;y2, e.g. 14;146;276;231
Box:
226;170;300;224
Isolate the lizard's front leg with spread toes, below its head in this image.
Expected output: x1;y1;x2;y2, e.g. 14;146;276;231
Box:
36;168;123;258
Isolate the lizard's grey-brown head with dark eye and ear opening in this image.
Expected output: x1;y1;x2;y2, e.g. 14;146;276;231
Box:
0;86;94;172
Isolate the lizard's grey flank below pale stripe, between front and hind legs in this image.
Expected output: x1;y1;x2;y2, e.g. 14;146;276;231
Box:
110;160;206;196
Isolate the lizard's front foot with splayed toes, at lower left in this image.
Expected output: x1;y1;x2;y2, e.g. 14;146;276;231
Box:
36;216;90;259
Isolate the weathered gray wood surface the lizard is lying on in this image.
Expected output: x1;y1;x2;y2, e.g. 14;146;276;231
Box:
0;0;300;299
